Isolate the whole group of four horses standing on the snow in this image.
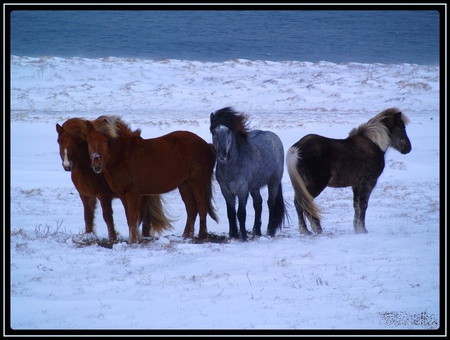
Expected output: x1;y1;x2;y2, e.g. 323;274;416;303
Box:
56;107;411;243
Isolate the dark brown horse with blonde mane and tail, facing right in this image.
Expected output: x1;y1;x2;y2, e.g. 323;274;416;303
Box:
286;108;411;234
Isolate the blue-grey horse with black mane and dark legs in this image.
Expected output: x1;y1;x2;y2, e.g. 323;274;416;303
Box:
210;107;286;240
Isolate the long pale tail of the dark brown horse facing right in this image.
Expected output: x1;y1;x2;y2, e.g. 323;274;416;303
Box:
286;146;319;219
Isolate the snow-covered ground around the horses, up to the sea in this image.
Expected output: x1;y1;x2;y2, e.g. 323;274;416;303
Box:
4;56;446;335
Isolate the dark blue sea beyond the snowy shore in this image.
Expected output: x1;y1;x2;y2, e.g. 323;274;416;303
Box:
10;10;444;65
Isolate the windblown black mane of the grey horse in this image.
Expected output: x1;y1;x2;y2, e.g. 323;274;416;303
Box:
210;106;249;139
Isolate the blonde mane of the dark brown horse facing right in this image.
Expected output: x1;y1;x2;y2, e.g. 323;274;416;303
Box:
349;107;409;152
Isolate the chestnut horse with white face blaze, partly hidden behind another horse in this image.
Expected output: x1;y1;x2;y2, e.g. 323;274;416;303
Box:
56;118;172;241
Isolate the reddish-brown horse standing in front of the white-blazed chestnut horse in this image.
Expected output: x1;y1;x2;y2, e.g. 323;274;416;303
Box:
86;116;217;243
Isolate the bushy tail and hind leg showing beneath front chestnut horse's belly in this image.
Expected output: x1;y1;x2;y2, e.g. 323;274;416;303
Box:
142;195;173;236
